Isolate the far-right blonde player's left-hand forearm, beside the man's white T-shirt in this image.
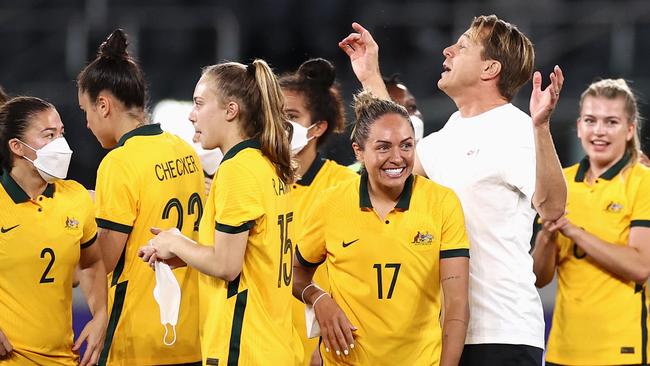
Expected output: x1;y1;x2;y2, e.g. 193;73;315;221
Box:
532;221;558;288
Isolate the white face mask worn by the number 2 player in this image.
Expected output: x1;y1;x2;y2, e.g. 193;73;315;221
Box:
18;136;72;183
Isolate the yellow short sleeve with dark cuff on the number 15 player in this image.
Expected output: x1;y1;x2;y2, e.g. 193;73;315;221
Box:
214;160;265;234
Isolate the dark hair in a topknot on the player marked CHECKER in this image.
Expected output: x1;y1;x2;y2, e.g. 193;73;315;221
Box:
77;29;147;110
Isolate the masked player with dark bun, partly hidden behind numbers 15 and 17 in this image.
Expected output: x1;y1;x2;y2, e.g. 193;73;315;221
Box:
279;58;357;365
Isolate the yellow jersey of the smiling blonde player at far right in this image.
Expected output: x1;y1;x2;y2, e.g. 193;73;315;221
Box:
546;156;650;365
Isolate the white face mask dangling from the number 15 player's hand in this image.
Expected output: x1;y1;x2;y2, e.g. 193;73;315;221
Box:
153;261;181;346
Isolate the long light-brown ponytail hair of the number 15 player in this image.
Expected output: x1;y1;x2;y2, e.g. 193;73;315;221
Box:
203;59;296;184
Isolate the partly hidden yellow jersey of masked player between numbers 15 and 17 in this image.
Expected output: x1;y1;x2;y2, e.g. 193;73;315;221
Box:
291;154;359;366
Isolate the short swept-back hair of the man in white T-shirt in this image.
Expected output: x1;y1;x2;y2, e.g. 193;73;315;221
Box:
470;15;535;101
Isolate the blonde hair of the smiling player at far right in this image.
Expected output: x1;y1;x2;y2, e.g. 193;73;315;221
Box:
579;79;641;163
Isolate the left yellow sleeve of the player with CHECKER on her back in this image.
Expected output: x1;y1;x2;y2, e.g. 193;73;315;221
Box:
95;153;138;234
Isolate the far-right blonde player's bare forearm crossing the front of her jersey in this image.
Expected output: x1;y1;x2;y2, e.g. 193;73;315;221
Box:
557;217;650;285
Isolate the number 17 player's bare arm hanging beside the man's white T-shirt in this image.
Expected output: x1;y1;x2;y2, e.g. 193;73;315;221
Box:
440;257;469;366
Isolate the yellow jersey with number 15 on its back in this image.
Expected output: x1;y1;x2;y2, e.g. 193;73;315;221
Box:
199;140;302;365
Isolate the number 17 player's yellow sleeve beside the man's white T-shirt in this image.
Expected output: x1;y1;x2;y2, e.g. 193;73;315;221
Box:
440;190;469;259
